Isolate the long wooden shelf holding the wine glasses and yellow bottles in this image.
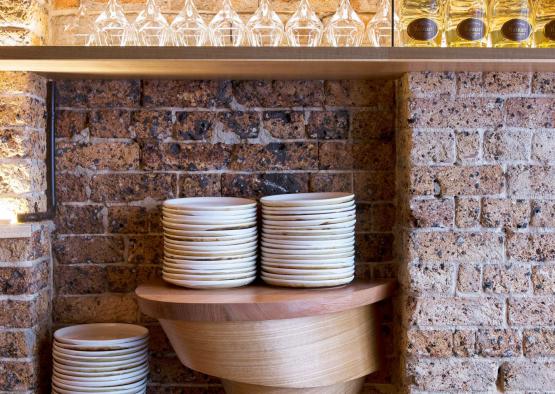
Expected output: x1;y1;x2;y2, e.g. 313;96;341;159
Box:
0;47;555;79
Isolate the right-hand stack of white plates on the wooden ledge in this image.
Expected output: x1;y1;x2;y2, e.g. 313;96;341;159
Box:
260;193;355;287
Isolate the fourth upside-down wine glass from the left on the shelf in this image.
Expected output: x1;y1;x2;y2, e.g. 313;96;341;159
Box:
171;0;208;47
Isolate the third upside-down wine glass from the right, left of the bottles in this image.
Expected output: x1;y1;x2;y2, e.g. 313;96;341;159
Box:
285;0;324;47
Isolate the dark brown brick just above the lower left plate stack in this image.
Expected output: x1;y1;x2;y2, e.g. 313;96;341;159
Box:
53;294;138;324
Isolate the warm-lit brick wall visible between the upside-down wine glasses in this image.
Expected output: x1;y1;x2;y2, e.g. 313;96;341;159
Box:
47;0;378;45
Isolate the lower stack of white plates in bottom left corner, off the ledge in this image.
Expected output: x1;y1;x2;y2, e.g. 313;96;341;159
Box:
52;323;148;394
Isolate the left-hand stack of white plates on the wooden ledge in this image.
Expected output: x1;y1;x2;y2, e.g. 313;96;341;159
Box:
162;197;258;289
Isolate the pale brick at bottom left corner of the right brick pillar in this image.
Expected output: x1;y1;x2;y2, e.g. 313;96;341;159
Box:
408;359;497;392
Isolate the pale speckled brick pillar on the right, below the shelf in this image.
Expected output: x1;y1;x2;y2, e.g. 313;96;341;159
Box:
398;73;555;393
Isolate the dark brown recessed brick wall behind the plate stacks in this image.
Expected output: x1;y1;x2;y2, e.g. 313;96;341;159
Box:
53;81;398;393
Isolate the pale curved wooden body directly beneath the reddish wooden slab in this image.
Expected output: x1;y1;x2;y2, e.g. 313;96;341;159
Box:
160;305;379;392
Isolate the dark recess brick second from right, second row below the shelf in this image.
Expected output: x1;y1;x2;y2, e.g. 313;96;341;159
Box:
306;110;350;140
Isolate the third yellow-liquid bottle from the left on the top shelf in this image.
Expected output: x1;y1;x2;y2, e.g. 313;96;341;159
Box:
489;0;535;48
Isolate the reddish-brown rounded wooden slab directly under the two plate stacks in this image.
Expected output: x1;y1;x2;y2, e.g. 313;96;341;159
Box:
135;280;397;321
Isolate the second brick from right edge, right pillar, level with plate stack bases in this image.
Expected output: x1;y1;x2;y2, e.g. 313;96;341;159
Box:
483;264;531;293
